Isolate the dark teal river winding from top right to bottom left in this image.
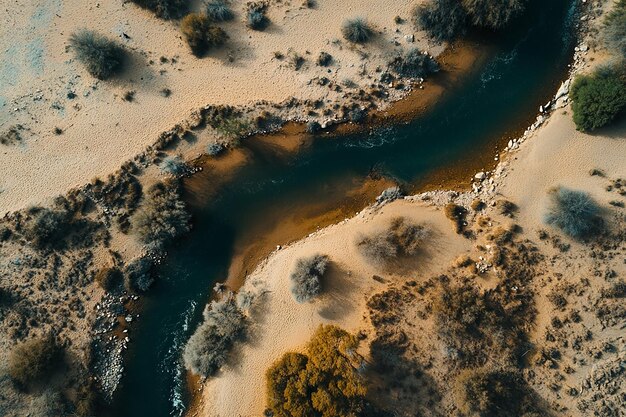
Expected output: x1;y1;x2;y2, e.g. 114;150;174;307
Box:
114;0;575;417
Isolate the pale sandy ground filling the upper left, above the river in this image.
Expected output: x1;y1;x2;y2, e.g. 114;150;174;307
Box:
0;0;434;213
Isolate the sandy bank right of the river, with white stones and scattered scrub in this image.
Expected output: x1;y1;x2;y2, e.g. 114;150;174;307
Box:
190;3;626;416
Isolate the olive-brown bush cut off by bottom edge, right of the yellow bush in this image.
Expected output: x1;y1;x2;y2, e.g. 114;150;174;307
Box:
456;369;539;417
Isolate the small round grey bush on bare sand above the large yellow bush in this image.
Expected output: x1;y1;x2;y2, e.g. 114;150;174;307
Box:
291;254;328;303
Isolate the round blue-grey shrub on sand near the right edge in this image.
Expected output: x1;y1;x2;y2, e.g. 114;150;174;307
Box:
545;187;601;238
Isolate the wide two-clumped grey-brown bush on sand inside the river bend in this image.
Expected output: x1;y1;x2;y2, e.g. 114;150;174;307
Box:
357;217;428;264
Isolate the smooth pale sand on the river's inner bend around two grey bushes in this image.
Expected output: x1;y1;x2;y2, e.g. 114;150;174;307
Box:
198;201;471;417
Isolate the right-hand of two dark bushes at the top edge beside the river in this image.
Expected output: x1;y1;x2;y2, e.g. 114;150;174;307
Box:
461;0;526;29
